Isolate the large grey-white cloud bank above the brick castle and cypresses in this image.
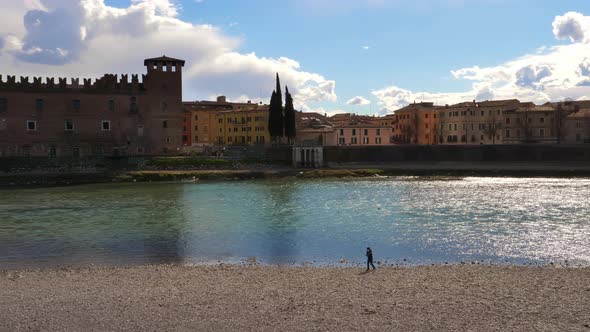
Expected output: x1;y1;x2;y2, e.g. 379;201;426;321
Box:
0;0;337;107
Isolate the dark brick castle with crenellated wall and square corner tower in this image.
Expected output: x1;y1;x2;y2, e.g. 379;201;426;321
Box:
0;56;184;157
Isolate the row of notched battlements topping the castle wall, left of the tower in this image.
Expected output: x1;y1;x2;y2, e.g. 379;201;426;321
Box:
0;74;147;94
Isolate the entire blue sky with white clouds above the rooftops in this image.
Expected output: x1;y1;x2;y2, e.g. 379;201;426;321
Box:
0;0;590;115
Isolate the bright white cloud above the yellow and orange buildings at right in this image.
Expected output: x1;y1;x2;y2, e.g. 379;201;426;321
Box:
373;12;590;112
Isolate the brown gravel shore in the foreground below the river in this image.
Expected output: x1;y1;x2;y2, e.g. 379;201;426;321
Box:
0;265;590;331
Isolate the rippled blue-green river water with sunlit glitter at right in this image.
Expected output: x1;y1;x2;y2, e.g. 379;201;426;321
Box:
0;178;590;268
